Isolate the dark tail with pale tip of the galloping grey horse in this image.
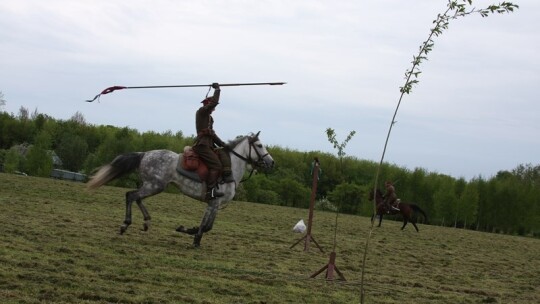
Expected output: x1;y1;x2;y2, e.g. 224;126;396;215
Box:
86;152;144;190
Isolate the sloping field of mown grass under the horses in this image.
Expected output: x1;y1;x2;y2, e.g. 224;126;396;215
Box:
0;173;540;303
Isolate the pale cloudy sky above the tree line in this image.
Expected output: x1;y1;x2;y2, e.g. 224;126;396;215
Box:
0;0;540;180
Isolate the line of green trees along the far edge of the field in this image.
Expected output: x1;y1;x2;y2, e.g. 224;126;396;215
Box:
0;107;540;236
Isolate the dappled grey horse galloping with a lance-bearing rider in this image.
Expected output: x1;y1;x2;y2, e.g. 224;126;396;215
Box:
88;132;274;247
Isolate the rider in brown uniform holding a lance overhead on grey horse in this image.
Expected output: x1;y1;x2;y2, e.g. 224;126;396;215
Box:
193;83;234;200
